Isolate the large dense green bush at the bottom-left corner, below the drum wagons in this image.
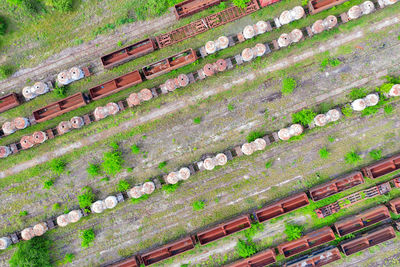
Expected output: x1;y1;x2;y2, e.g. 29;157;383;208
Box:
9;236;53;267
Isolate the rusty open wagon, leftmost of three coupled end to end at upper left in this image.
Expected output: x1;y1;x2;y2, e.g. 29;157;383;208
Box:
33;93;86;122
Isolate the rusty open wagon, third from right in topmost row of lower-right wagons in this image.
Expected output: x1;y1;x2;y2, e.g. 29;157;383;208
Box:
255;193;310;222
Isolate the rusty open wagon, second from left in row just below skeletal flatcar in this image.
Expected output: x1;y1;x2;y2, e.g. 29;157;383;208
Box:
277;226;335;258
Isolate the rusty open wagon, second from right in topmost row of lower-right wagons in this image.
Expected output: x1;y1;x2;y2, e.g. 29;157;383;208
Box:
308;172;364;201
